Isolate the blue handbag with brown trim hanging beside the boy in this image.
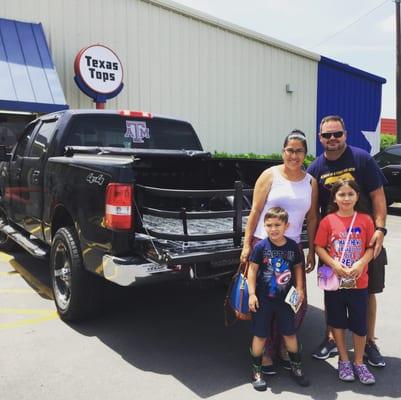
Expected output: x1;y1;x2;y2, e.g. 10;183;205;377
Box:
224;263;252;326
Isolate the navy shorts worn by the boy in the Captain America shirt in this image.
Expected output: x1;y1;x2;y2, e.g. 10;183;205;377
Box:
252;297;296;338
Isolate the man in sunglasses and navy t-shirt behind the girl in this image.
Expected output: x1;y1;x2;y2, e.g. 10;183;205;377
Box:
308;115;387;367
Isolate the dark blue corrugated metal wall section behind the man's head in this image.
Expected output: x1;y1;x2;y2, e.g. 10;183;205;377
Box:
316;57;386;154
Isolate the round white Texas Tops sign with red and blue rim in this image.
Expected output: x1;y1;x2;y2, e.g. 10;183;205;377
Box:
74;44;124;108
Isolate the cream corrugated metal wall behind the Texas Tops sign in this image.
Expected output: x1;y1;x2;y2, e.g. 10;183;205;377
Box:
2;0;318;154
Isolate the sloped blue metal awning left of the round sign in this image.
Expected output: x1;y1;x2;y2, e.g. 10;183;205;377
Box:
0;18;68;113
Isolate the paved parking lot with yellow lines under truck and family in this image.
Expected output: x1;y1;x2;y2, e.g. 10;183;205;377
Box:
0;205;401;400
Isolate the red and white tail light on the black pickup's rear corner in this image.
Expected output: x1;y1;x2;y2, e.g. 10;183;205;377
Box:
105;183;133;229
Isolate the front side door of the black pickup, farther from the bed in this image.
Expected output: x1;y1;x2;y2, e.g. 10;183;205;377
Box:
6;123;38;226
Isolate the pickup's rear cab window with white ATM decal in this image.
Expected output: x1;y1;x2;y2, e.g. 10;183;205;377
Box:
65;115;202;150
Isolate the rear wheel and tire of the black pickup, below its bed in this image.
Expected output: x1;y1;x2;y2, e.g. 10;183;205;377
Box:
50;227;101;322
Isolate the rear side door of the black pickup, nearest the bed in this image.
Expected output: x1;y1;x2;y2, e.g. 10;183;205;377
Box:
21;119;57;239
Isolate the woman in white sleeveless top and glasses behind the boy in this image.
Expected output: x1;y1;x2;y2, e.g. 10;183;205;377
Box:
241;130;318;372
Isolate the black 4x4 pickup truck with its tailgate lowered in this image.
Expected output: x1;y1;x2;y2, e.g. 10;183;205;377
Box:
0;110;277;321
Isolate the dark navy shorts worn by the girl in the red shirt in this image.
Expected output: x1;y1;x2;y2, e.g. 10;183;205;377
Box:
324;289;368;336
